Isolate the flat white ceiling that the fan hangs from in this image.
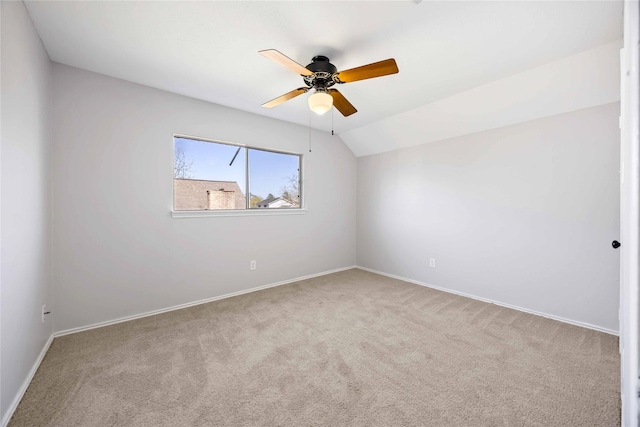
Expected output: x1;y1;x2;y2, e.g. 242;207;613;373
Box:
26;0;622;153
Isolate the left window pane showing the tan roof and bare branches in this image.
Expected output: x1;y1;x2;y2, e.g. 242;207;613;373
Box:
173;138;247;211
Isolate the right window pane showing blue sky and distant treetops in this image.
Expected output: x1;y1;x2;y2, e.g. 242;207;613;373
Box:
249;149;300;209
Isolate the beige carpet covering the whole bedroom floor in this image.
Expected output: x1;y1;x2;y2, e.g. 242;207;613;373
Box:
9;270;620;427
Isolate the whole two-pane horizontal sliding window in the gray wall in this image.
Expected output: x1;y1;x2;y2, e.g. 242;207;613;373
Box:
173;135;301;211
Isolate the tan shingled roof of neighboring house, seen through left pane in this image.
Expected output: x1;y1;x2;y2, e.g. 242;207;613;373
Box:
173;178;247;211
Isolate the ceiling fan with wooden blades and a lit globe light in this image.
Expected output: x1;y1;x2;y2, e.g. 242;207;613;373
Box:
258;49;398;117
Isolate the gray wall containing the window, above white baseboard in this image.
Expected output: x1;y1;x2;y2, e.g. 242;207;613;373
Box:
53;64;357;331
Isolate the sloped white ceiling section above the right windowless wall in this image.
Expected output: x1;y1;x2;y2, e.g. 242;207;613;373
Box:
340;40;622;157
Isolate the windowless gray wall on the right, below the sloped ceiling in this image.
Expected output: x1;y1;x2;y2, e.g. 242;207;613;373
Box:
357;103;620;331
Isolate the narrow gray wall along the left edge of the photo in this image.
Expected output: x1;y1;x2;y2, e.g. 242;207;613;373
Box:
0;1;52;422
